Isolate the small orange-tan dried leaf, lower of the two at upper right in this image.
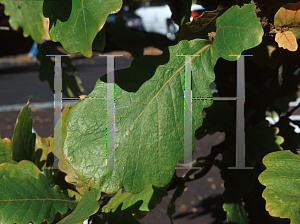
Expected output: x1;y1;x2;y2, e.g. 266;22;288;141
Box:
275;31;298;51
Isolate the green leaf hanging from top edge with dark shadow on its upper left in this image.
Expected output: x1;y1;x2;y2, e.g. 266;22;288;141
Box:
44;0;122;57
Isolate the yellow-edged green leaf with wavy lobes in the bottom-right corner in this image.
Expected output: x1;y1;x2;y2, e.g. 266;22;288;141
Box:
258;151;300;224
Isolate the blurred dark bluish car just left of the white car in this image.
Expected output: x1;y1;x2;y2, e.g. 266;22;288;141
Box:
106;5;144;30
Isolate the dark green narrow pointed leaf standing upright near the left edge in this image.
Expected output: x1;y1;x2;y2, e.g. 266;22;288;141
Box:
12;100;36;163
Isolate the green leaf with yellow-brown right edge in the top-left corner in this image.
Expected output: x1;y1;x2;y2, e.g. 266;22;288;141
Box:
0;0;50;44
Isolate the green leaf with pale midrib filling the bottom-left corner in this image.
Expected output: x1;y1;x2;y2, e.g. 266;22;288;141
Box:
0;160;78;223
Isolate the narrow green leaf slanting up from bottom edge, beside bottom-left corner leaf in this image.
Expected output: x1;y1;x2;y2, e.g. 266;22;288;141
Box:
58;189;100;224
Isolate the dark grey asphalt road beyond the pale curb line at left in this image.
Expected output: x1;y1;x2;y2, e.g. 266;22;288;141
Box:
0;52;132;105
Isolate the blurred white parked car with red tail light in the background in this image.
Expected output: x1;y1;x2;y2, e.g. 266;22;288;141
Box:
134;0;205;40
